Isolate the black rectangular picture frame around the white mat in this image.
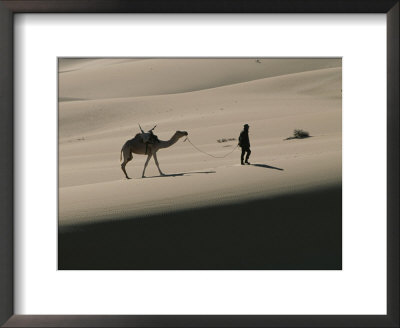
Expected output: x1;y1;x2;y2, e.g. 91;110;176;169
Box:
0;0;400;327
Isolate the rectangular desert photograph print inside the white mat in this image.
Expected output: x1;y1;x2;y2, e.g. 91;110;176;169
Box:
57;57;342;270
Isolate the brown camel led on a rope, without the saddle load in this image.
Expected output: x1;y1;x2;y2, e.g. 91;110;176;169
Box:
120;131;188;179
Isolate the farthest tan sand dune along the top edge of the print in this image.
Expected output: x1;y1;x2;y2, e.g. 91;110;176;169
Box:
59;58;341;100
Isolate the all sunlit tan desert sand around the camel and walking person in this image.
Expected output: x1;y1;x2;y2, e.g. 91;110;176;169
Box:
58;58;342;270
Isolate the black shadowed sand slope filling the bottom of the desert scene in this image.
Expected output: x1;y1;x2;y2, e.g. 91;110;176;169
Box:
58;186;342;270
